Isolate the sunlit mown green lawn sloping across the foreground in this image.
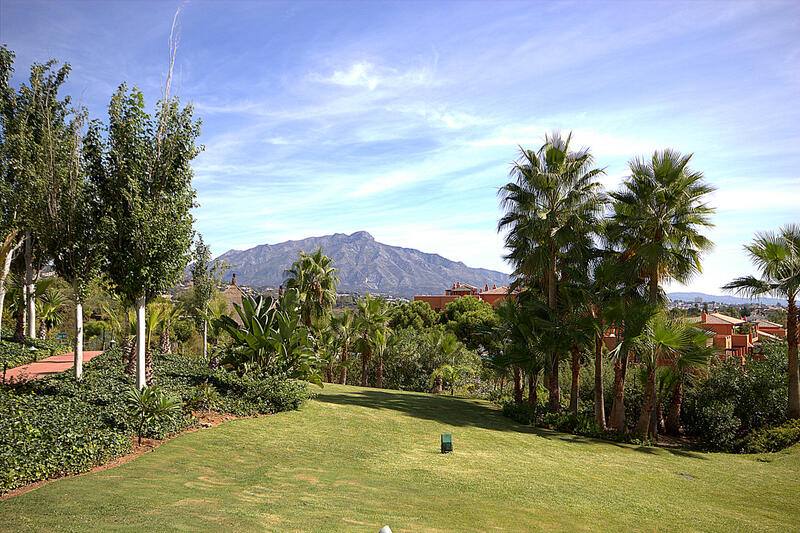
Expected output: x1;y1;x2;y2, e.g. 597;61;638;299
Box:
0;385;800;533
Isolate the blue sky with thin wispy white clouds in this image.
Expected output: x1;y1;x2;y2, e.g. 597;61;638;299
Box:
0;0;800;293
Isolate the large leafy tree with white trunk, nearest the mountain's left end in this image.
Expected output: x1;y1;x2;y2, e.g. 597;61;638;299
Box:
84;84;200;388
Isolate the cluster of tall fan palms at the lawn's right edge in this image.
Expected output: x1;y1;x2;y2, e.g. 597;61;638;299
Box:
496;133;713;434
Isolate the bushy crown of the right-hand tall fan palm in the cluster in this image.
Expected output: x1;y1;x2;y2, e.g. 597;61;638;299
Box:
607;149;714;304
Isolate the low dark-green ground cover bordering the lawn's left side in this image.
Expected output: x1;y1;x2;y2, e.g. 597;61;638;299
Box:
0;349;309;493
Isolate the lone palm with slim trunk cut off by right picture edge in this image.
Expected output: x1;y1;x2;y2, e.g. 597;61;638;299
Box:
723;224;800;419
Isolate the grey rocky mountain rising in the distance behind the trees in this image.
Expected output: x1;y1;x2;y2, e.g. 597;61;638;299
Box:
218;231;510;297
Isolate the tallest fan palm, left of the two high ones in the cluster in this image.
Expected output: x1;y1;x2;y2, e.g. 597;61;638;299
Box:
498;133;604;410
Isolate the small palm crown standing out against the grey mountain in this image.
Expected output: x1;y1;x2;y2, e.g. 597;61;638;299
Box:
284;248;339;326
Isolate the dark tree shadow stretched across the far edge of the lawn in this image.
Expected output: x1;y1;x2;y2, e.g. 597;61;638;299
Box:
316;389;707;460
